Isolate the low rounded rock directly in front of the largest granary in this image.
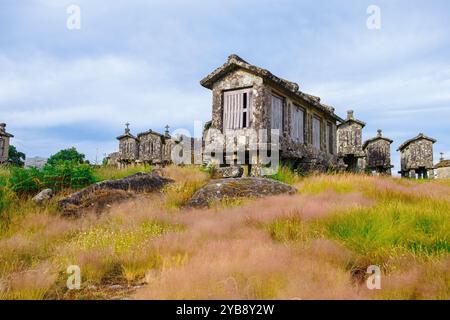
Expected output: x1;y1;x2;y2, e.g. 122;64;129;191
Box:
188;177;297;207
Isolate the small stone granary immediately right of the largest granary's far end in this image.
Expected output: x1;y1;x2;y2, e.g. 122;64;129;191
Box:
337;110;366;172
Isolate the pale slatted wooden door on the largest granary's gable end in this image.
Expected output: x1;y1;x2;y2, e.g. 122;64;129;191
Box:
223;89;252;130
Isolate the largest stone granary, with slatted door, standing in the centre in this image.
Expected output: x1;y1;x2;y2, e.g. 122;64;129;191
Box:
200;55;343;176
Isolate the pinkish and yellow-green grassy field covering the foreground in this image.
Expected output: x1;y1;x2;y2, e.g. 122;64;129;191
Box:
0;167;450;299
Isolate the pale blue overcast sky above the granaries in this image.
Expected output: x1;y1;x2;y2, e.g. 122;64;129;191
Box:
0;0;450;170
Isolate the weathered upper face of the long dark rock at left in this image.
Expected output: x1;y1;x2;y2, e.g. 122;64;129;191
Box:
58;173;172;211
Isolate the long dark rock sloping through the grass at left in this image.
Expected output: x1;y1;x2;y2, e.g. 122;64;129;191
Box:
58;173;173;214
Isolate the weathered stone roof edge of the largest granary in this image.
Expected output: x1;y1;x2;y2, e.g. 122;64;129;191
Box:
200;54;344;122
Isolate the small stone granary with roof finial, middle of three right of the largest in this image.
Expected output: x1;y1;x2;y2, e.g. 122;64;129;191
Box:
363;129;394;175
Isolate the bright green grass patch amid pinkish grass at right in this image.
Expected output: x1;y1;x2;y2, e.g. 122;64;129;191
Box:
323;199;450;259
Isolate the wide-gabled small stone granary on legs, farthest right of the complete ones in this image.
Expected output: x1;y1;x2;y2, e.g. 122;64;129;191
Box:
397;133;436;179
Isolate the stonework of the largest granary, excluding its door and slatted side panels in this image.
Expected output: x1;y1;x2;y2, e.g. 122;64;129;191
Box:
201;56;341;175
